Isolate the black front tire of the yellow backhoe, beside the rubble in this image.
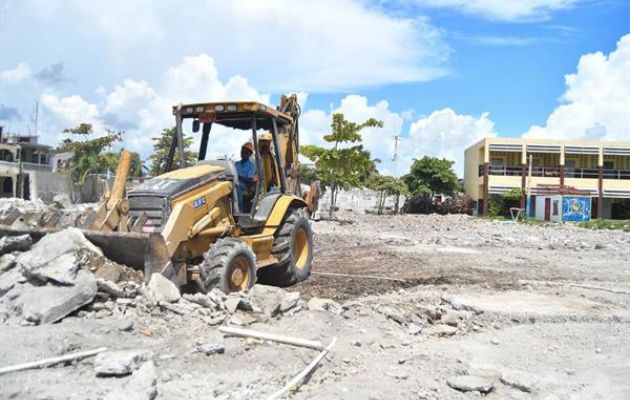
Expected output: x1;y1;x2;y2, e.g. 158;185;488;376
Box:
197;238;256;293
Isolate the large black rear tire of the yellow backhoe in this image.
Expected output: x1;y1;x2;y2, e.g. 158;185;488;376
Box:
258;209;313;287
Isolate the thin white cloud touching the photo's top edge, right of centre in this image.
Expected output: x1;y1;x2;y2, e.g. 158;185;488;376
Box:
415;0;583;21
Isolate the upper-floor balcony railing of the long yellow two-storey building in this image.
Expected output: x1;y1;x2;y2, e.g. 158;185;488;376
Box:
478;165;630;180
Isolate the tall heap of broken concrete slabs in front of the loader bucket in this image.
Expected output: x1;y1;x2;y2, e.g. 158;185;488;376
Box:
0;228;142;325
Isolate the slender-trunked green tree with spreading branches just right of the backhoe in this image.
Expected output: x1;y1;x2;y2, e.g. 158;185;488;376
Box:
300;113;383;219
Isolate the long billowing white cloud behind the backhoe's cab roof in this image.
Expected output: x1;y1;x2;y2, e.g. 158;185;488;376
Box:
41;54;269;161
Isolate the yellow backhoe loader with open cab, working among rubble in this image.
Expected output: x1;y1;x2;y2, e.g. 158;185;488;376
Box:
0;95;317;292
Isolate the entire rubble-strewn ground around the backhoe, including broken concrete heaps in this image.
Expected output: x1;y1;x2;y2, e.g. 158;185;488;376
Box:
0;199;630;400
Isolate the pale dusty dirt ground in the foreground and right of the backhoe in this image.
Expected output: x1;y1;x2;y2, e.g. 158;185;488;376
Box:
0;213;630;400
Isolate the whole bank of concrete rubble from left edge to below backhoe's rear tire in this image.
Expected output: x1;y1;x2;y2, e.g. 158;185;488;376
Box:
0;228;305;326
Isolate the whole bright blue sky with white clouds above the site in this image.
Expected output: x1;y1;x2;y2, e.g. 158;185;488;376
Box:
0;0;630;173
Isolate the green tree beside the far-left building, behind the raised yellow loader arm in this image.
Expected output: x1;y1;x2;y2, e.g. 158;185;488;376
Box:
58;123;123;183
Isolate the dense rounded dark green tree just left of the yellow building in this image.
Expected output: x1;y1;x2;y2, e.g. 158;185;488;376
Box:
402;156;457;197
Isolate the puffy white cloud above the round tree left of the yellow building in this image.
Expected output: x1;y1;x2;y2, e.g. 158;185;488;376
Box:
402;108;496;176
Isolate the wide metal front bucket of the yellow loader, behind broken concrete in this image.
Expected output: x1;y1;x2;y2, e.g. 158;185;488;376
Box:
0;225;170;279
